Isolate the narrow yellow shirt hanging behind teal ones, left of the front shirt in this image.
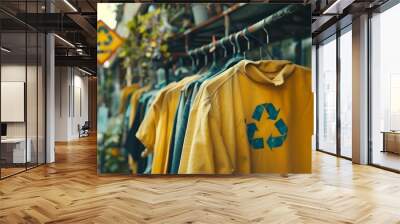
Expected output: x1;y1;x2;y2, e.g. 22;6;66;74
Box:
136;76;198;174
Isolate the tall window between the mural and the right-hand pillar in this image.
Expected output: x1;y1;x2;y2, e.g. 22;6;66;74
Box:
315;24;352;160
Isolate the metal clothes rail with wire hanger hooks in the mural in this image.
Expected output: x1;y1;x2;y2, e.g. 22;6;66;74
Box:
187;4;300;56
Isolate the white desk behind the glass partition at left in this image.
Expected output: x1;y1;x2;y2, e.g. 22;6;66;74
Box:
1;138;32;163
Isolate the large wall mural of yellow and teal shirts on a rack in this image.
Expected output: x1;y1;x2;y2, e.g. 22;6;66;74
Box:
97;3;314;175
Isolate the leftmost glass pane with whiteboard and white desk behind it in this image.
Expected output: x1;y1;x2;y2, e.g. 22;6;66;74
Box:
0;32;27;177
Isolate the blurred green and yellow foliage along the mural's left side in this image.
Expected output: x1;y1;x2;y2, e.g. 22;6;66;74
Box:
98;4;192;173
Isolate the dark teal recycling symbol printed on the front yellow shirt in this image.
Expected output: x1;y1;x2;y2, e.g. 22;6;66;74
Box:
247;103;288;150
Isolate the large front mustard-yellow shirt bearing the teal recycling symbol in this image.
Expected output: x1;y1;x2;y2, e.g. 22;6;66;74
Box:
179;60;313;174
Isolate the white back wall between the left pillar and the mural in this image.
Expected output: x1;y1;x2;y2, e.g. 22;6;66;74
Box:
55;67;89;141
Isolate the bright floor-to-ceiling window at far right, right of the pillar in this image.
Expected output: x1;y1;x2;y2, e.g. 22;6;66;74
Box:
370;4;400;171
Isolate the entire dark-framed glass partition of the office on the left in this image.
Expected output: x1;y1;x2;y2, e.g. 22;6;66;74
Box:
0;1;46;179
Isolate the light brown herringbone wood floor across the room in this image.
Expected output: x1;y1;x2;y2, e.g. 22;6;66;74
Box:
0;134;400;224
